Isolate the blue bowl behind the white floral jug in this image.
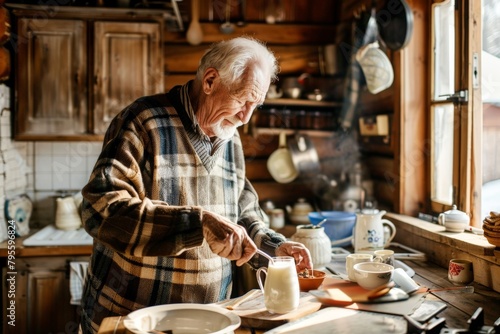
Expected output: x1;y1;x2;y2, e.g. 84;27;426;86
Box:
309;211;356;247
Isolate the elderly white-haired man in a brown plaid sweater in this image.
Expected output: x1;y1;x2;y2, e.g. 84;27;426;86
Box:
82;37;311;333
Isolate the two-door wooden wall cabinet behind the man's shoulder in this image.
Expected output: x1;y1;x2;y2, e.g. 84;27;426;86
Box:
8;6;163;141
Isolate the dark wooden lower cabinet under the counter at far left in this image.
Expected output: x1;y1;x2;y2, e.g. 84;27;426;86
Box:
2;256;89;334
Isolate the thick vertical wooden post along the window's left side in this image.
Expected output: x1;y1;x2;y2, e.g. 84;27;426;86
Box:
393;0;430;216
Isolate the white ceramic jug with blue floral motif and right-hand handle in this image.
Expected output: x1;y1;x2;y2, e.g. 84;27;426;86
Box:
354;210;396;253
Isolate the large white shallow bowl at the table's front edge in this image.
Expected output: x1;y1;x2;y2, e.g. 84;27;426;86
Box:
123;304;241;334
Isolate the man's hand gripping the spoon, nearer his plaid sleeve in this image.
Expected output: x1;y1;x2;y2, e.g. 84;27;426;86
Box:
202;211;257;266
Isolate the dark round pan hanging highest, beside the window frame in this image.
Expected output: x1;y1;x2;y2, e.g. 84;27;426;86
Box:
377;0;413;51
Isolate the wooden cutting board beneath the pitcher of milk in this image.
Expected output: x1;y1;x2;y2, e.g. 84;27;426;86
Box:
220;290;321;329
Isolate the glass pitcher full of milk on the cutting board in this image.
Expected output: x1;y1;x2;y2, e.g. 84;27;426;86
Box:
257;256;300;314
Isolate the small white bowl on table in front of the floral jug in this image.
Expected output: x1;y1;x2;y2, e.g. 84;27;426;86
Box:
353;262;394;290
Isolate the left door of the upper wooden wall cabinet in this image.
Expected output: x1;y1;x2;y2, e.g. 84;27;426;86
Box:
16;18;88;139
